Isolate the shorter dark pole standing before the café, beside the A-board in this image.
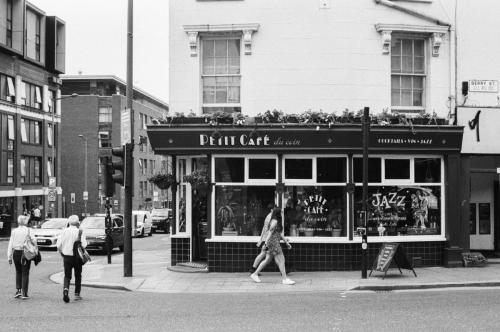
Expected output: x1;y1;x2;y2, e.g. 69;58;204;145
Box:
361;107;370;279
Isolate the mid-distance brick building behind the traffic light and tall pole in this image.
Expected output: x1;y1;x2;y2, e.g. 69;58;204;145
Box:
61;75;169;215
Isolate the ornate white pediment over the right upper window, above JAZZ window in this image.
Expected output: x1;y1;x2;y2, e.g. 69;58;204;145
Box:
375;24;449;56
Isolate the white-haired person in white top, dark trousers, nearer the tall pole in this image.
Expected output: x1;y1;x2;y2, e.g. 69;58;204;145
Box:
57;215;87;303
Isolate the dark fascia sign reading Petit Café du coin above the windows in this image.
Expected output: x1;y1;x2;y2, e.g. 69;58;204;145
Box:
148;126;462;154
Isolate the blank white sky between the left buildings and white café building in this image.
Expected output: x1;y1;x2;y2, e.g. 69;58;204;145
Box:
29;0;169;102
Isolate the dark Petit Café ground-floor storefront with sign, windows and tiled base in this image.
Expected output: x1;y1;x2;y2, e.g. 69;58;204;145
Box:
148;125;463;272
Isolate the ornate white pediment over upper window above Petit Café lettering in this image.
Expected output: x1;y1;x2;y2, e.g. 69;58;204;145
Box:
183;23;259;56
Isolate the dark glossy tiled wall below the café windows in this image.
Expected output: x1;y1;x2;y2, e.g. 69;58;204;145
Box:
203;239;445;272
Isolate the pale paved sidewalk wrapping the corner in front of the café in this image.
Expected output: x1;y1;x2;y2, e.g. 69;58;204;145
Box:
50;251;500;293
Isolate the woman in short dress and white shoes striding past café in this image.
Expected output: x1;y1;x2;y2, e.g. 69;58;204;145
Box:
250;208;295;285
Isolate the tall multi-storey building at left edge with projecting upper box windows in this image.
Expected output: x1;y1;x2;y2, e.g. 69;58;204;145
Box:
0;0;66;235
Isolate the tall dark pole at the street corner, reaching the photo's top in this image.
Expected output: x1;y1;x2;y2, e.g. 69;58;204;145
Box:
123;0;134;277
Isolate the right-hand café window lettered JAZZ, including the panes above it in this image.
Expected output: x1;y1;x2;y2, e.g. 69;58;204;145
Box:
354;157;443;236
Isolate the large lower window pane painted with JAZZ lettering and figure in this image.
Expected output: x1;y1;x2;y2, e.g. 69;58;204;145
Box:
354;186;441;236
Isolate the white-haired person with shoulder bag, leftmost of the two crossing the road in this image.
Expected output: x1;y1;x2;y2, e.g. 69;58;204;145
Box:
7;215;36;300
